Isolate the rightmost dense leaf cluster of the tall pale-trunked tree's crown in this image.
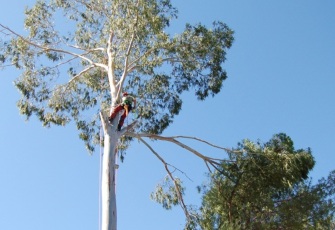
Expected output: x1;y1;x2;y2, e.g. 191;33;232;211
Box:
171;22;233;100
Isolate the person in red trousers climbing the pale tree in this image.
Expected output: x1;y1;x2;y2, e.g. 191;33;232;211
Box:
108;92;136;131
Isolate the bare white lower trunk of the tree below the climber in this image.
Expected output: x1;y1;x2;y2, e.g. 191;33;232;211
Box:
101;121;119;230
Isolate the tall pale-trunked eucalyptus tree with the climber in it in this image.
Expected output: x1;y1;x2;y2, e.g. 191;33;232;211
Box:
0;0;233;230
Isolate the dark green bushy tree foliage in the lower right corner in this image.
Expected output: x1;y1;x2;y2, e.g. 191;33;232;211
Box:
193;133;335;230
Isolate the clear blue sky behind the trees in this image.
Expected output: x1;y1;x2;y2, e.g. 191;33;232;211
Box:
0;0;335;230
